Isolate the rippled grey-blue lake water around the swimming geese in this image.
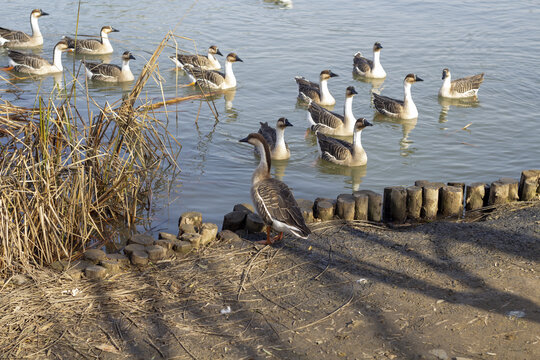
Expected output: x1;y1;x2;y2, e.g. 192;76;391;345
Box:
0;0;540;232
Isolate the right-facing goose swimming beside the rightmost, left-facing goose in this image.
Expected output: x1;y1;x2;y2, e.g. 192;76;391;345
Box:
372;74;424;119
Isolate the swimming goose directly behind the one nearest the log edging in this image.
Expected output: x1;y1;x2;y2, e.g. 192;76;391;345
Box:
304;86;358;136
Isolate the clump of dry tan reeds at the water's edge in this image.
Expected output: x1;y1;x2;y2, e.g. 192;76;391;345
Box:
0;34;179;273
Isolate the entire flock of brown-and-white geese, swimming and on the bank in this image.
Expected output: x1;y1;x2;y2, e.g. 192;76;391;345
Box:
0;9;484;244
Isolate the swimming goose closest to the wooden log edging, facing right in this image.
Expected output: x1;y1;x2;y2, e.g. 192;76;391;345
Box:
316;118;373;166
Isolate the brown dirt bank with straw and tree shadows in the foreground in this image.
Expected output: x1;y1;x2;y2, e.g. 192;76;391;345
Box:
0;203;540;360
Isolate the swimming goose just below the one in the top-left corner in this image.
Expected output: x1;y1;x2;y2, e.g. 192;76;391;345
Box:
3;40;68;75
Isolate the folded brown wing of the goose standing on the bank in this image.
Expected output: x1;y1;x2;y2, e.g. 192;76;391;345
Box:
251;178;311;236
